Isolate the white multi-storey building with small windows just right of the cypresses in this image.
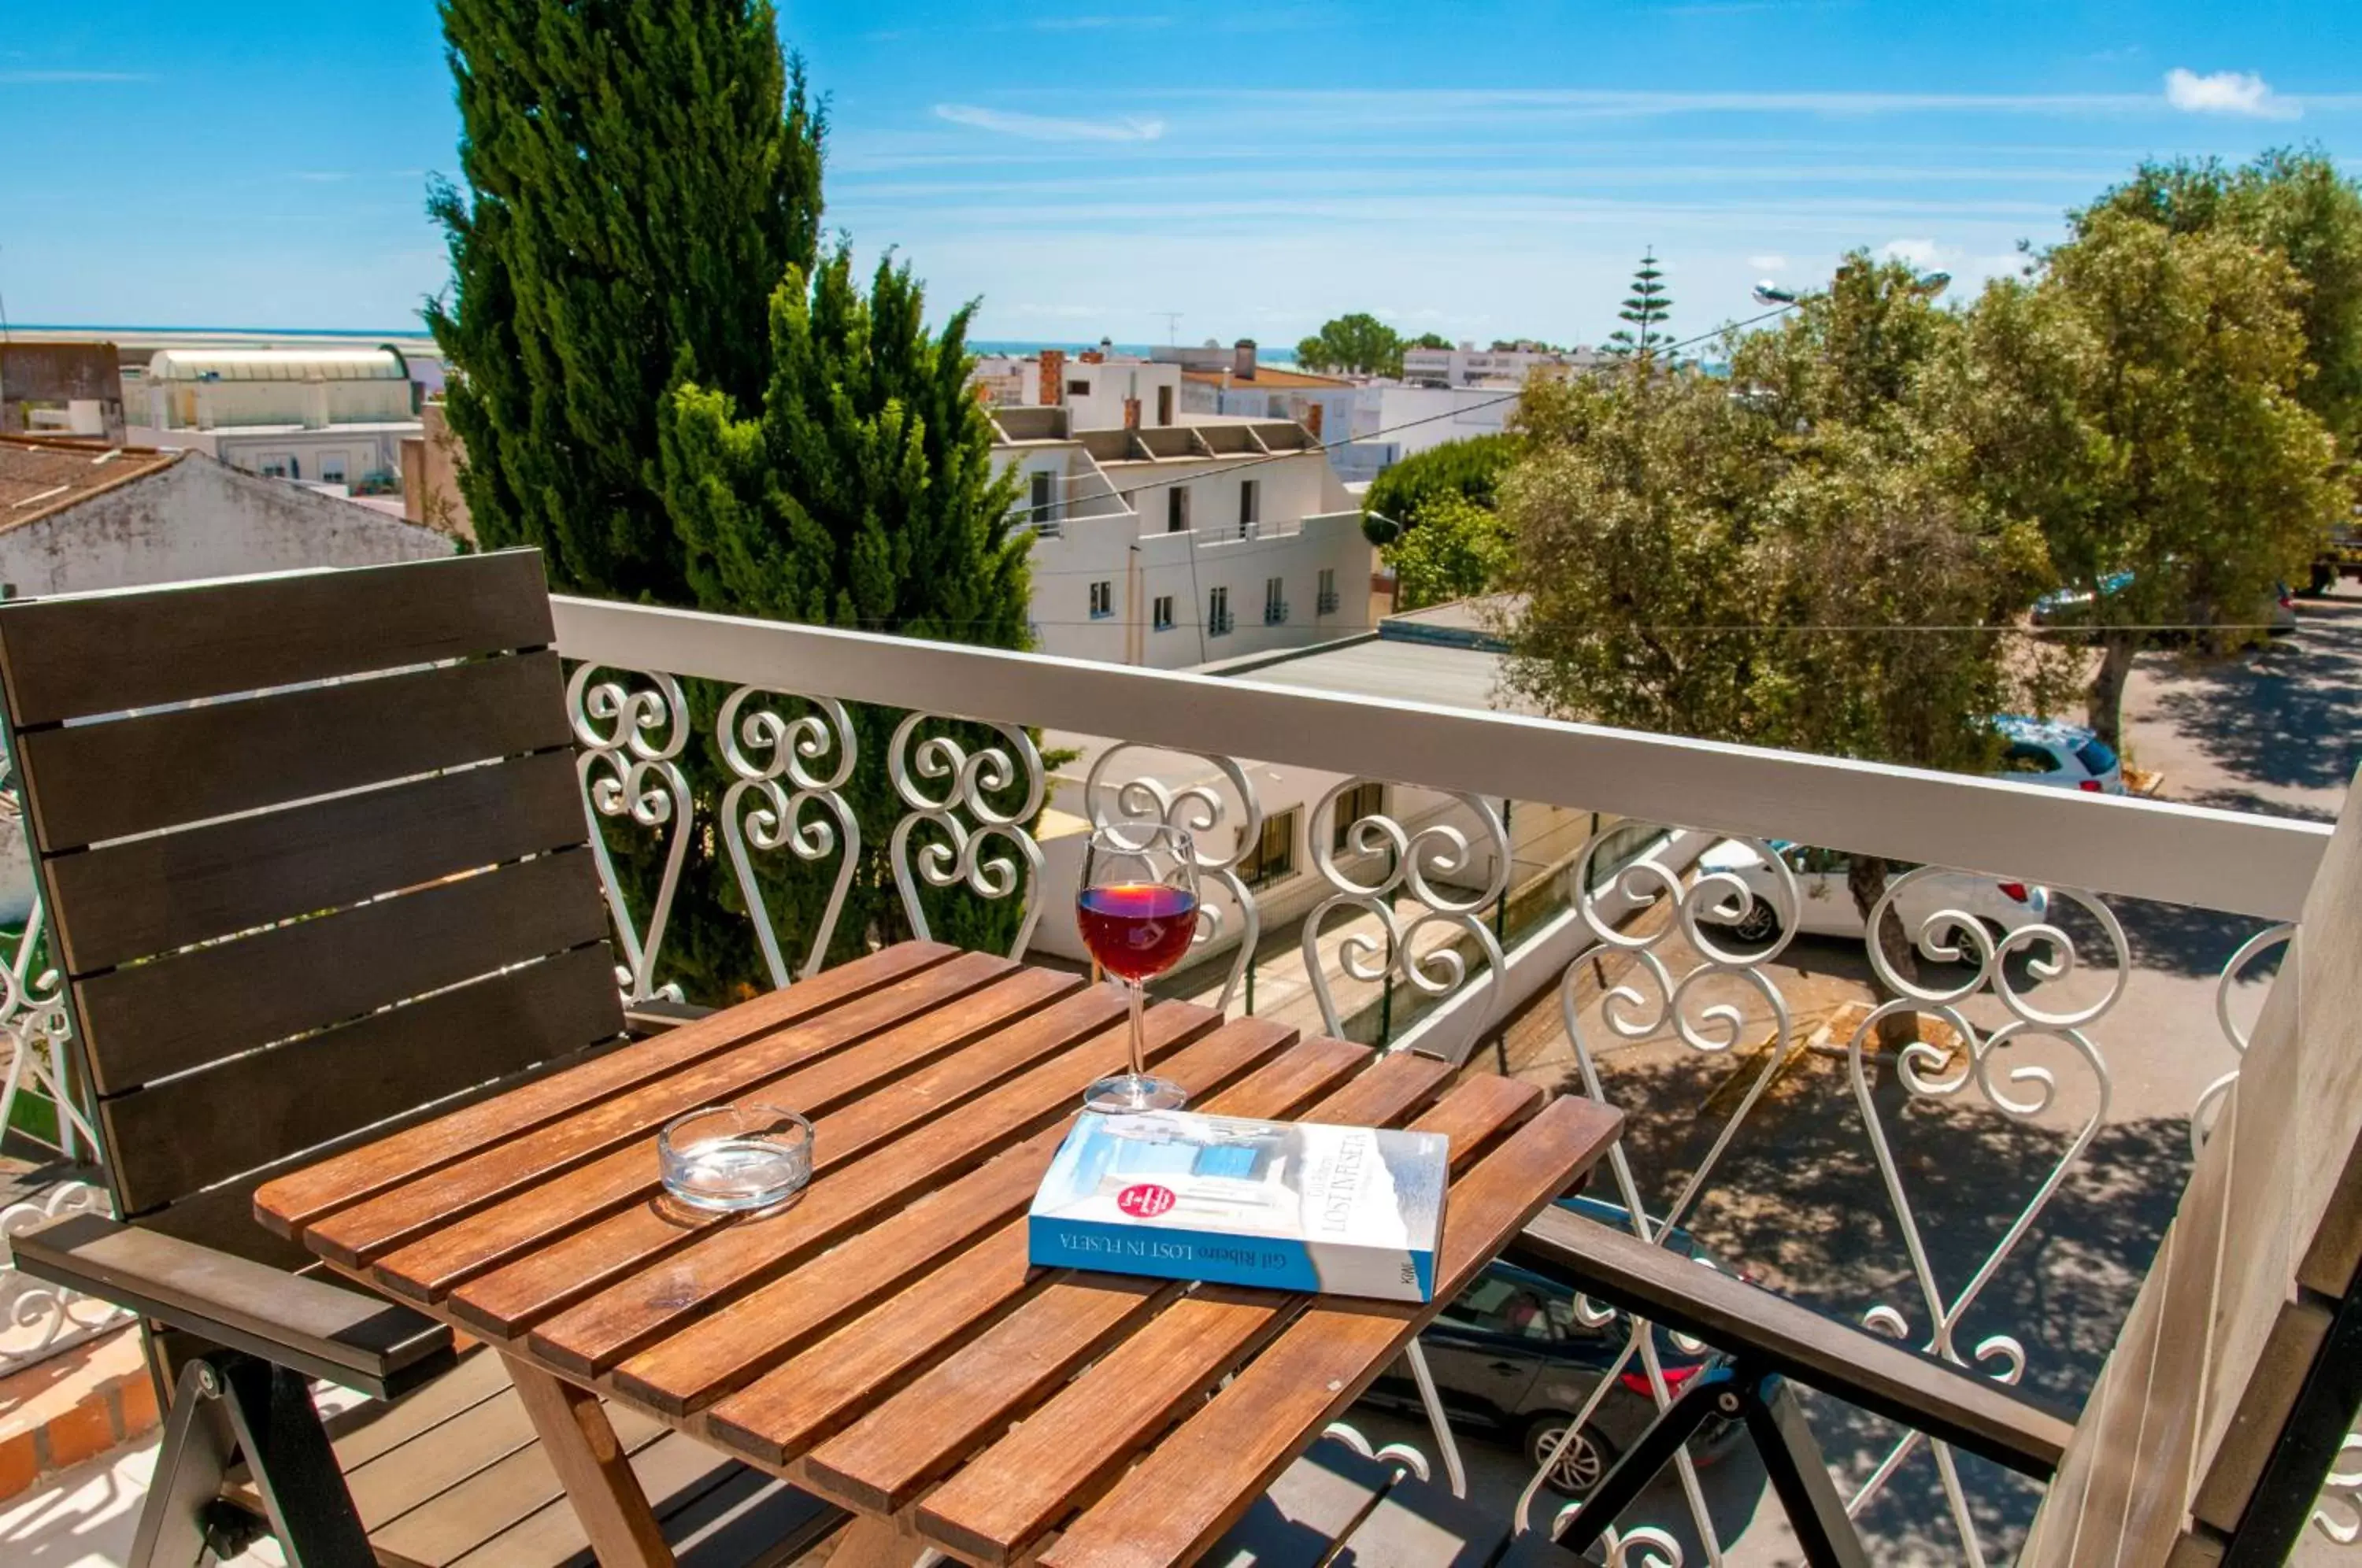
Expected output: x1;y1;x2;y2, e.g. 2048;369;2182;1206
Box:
994;406;1377;668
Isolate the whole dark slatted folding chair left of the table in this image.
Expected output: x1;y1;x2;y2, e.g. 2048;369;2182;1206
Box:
0;550;841;1568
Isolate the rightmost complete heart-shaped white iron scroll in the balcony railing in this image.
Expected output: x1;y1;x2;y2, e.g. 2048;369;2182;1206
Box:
1847;867;2131;1566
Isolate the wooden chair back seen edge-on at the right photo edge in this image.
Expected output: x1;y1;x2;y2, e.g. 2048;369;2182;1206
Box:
2017;789;2362;1568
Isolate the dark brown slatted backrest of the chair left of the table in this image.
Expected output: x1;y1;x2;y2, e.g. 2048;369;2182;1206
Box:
0;550;624;1266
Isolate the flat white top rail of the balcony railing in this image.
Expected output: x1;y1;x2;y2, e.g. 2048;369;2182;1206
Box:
555;597;2329;921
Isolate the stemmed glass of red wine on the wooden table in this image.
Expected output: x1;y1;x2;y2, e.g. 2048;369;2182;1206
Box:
1075;824;1198;1115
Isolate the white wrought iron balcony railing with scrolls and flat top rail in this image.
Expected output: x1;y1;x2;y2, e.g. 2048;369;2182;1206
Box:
557;597;2353;1566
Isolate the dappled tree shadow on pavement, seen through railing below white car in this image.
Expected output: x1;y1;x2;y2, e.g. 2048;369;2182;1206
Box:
1559;1034;2190;1561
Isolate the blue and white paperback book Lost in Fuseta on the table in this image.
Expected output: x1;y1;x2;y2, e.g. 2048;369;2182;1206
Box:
1025;1110;1450;1301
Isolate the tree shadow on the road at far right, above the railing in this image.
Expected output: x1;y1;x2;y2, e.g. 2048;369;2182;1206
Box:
2154;602;2362;798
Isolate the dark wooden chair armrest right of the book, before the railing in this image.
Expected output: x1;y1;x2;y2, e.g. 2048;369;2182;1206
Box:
1509;1207;2074;1481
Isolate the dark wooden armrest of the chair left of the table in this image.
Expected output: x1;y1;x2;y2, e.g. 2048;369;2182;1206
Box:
14;1214;458;1398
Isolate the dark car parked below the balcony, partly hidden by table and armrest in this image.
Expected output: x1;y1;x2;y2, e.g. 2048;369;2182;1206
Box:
1365;1197;1741;1497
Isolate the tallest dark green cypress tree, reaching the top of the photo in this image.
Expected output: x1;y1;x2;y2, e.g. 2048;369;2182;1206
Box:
425;0;824;605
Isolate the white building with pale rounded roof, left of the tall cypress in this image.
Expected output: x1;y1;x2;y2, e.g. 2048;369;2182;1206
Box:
125;347;423;494
